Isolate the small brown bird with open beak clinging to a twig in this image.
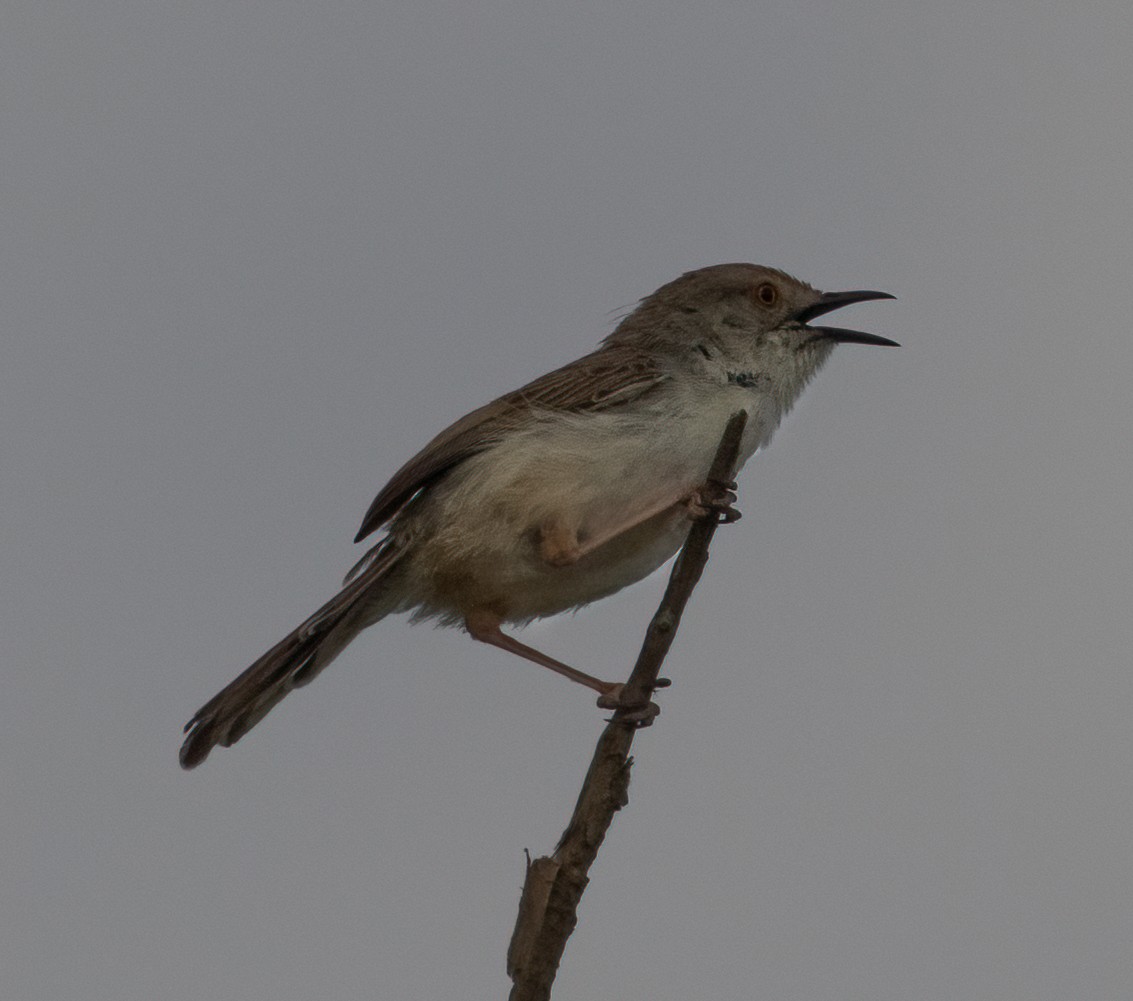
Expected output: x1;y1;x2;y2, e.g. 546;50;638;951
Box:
180;263;897;769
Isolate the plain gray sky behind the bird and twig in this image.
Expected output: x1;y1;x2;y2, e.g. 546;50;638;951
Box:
0;0;1133;1001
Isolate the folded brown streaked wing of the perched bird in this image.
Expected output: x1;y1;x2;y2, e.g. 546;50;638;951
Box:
355;345;667;542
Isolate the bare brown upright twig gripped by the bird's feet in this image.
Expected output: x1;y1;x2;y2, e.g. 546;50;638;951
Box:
508;410;748;1001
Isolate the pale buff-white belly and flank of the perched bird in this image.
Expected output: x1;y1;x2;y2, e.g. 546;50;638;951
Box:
394;400;755;623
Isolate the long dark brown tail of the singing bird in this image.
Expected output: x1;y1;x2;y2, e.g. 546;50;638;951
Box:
180;540;403;769
